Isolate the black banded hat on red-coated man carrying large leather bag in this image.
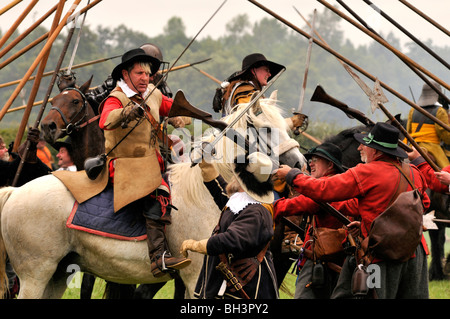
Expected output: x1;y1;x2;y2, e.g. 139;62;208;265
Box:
353;122;408;158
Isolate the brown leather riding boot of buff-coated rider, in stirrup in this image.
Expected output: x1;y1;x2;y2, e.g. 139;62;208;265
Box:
145;218;191;277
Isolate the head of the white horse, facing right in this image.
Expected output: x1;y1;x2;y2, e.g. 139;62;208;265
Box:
210;93;306;179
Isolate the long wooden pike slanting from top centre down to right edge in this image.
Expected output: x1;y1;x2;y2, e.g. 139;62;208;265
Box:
248;0;450;132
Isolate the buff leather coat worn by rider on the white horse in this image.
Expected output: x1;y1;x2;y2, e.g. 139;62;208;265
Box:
54;84;165;211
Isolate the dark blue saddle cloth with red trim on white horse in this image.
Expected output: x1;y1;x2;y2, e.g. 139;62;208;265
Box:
66;186;147;240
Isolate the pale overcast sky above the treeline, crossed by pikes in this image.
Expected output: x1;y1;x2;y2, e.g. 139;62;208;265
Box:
0;0;450;49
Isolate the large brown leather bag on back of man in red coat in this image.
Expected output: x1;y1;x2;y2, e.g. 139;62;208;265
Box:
368;165;423;262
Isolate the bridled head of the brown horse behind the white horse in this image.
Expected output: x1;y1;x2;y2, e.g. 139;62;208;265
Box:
41;77;92;144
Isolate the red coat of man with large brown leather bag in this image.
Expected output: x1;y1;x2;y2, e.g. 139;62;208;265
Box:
286;156;430;237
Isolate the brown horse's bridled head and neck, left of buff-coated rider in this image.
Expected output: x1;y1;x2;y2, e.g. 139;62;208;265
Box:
41;77;105;170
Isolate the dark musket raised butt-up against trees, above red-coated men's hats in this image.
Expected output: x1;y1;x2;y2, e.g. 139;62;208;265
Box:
311;85;412;152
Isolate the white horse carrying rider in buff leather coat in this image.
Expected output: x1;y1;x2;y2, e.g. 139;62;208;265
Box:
0;95;305;299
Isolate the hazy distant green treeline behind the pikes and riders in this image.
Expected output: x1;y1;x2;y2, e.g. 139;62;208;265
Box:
0;9;450;139
